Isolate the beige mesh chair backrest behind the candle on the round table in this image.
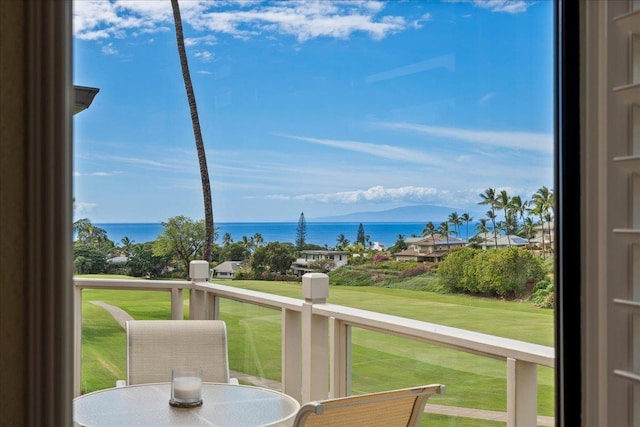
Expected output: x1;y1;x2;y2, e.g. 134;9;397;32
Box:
126;320;229;385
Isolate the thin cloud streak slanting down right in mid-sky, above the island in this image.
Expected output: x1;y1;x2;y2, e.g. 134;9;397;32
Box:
276;134;440;165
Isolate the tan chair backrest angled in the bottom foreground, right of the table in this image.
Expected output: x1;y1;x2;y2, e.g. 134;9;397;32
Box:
293;384;446;427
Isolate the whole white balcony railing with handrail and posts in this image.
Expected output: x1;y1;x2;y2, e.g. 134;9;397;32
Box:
74;261;555;426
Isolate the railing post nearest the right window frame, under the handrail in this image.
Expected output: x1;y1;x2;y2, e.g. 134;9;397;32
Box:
507;357;538;427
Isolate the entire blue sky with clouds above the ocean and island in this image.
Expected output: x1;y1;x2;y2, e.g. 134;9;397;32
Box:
73;0;553;223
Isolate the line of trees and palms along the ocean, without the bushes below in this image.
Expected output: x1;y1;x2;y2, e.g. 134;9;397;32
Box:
74;187;554;278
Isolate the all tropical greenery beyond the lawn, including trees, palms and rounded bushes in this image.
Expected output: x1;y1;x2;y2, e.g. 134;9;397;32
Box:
74;187;554;307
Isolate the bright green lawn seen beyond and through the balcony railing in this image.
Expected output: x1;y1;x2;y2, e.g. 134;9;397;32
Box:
82;281;554;426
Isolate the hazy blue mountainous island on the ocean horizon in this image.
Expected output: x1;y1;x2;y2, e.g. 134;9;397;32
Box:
307;205;485;223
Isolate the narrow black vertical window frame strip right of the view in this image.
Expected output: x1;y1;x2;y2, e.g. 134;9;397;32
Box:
554;0;583;426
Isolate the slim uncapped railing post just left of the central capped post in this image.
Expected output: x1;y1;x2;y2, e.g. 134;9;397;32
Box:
281;308;302;402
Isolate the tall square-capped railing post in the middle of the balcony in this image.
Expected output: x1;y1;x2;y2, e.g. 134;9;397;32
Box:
301;273;329;403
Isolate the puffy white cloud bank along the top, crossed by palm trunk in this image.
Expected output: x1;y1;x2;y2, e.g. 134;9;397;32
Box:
73;0;410;45
